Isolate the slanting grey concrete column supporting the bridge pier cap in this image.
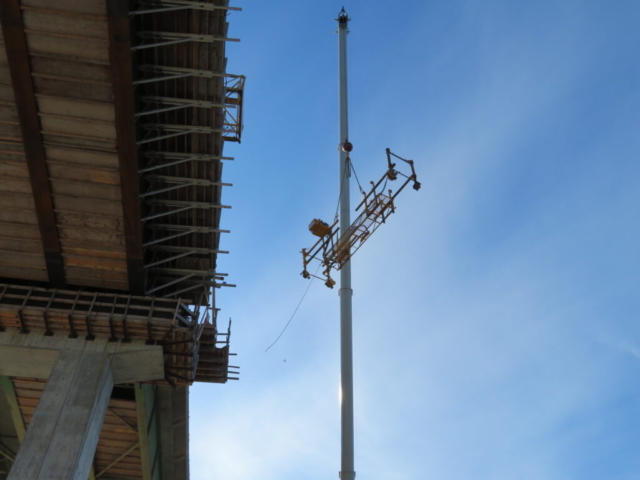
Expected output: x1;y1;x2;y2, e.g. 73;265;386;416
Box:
8;339;115;480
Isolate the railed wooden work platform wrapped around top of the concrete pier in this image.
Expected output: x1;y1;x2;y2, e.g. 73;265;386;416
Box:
0;284;229;385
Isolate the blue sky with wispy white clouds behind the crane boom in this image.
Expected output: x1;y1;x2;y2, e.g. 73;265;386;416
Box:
191;0;640;480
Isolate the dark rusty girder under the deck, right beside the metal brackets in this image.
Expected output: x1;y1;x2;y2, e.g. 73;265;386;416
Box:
107;0;145;295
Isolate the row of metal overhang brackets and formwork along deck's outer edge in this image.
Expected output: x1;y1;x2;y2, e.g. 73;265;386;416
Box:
130;0;245;307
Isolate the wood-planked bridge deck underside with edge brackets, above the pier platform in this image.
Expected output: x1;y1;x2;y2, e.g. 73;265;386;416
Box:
0;0;244;304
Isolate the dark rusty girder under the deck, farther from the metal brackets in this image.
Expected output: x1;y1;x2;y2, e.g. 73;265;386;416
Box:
0;0;65;288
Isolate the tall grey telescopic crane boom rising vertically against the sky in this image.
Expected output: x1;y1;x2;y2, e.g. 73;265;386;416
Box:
337;8;356;480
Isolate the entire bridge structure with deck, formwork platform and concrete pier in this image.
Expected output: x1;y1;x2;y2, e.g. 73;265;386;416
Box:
0;0;244;480
